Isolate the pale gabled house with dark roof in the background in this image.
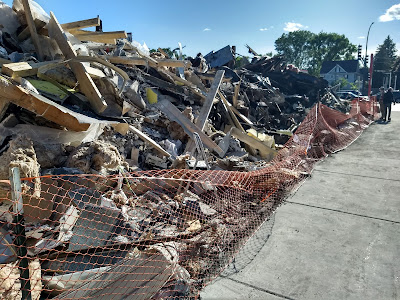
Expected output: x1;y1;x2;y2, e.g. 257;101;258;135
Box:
320;59;362;89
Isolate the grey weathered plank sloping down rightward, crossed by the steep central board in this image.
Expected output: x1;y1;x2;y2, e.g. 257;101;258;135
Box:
156;100;224;157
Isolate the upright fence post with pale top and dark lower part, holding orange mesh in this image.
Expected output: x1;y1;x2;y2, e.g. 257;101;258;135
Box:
10;167;31;300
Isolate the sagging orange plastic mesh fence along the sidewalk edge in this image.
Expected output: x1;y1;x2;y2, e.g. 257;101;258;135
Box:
0;101;378;300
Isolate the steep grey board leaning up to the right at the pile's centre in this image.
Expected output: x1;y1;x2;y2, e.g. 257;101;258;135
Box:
185;70;225;152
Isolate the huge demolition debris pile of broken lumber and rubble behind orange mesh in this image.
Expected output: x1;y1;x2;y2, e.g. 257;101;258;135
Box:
0;0;356;299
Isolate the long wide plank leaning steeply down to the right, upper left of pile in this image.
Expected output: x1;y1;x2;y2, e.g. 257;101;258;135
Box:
48;12;107;113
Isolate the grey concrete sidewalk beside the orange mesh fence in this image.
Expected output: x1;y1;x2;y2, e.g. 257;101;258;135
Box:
201;110;400;300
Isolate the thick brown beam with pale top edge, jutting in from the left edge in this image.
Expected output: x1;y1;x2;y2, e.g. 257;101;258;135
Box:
0;76;117;131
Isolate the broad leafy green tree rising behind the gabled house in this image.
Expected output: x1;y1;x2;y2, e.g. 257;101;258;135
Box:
275;30;357;76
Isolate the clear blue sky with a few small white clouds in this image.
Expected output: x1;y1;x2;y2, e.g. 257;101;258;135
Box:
3;0;400;56
